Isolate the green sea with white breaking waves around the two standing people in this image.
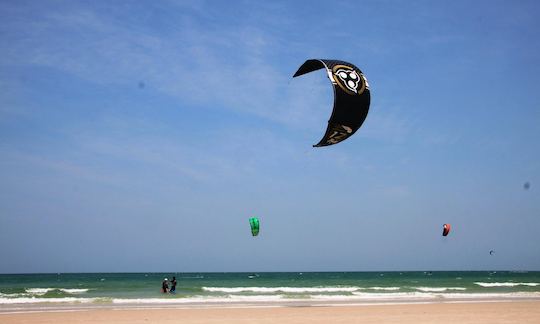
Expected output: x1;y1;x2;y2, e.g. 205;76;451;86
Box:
0;271;540;305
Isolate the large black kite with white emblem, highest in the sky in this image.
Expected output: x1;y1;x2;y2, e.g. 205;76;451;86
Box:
293;59;371;147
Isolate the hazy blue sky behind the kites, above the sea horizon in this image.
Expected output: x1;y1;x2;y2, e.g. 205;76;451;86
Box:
0;0;540;273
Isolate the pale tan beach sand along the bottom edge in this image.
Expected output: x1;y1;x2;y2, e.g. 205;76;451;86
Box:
0;300;540;324
